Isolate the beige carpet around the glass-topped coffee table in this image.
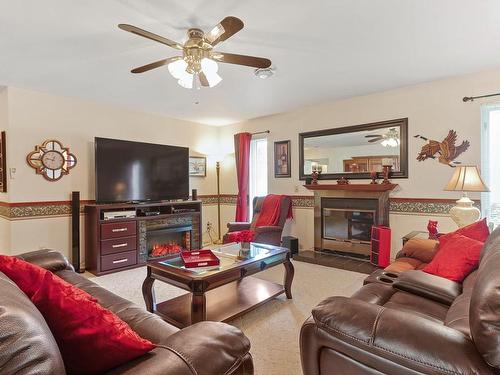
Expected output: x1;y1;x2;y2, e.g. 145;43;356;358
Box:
86;262;366;375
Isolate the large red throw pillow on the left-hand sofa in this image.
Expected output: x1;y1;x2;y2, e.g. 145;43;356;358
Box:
0;255;155;374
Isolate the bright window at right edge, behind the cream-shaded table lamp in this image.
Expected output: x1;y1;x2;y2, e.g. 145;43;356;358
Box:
481;104;500;231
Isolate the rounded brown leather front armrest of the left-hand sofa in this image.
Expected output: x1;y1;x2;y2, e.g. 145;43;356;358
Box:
108;322;254;375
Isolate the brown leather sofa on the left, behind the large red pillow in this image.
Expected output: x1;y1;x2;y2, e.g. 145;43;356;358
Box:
0;250;253;375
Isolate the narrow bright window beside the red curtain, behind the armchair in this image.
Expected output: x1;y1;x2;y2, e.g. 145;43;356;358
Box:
249;138;267;218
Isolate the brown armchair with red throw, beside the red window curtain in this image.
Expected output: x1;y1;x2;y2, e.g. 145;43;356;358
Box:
224;197;291;246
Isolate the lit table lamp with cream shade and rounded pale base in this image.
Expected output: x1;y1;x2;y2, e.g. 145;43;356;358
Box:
444;165;489;227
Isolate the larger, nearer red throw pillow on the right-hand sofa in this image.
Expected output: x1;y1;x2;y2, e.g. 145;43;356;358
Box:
422;234;484;282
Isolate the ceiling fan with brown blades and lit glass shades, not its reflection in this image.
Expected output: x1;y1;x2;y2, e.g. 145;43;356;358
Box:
118;17;271;89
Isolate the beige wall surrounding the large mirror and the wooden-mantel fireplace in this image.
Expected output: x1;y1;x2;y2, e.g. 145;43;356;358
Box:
221;70;500;253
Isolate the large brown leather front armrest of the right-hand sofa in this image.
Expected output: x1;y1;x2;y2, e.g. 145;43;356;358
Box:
312;297;493;374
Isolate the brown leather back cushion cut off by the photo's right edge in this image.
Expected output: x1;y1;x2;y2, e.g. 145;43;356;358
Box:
469;247;500;368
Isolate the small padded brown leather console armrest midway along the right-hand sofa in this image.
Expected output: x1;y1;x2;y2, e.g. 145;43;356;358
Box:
392;270;462;305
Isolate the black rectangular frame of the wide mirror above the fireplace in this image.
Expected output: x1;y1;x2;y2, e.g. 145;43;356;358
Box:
299;118;408;180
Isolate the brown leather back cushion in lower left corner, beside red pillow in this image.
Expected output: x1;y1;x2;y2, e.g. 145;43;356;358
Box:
0;272;66;375
